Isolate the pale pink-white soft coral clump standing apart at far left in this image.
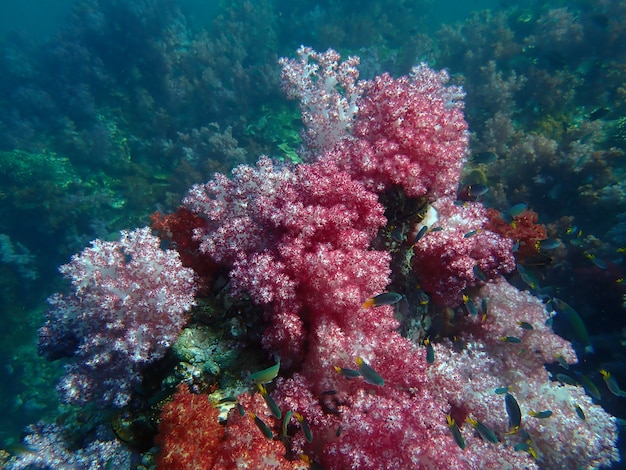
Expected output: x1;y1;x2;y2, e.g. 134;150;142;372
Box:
39;227;195;407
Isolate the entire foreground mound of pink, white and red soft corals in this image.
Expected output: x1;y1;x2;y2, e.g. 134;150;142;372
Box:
13;47;619;469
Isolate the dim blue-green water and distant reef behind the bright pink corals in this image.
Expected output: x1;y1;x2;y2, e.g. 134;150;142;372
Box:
0;0;626;468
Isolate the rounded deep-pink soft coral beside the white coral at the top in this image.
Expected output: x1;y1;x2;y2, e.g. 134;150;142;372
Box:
333;64;469;200
